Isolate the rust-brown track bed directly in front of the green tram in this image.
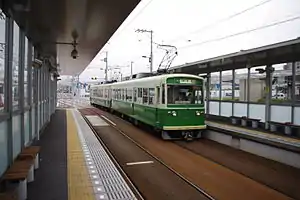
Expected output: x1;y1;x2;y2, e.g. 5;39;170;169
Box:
175;139;300;199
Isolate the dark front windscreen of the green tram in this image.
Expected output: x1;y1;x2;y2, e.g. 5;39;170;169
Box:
167;85;203;104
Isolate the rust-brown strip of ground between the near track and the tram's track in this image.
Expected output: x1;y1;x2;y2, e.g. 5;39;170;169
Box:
79;109;291;199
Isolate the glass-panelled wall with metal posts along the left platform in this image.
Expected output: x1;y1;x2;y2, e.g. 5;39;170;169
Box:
0;10;57;177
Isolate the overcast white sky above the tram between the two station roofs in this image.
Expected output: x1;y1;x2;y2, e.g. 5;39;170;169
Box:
80;0;300;82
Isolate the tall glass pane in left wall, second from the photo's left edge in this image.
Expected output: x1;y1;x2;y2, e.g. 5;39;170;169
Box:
12;22;20;110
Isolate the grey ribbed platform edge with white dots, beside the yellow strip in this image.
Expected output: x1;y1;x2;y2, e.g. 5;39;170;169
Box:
72;109;137;200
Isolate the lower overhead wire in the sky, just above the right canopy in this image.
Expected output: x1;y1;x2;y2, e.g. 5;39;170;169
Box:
179;15;300;49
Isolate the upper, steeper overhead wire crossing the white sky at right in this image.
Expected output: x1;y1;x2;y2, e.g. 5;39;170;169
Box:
168;0;273;43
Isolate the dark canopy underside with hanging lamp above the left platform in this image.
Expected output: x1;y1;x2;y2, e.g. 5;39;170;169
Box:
0;0;140;75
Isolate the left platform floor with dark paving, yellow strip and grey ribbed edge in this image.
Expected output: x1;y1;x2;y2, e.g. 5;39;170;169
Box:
28;109;137;200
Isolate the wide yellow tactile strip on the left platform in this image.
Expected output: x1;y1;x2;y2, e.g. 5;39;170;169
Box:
67;110;95;200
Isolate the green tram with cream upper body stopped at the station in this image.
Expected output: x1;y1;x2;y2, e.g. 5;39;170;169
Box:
90;74;206;140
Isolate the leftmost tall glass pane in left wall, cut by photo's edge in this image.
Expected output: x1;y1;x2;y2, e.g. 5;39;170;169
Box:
0;9;6;112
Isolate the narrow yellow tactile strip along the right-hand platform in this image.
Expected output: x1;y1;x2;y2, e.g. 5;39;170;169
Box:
207;121;300;143
